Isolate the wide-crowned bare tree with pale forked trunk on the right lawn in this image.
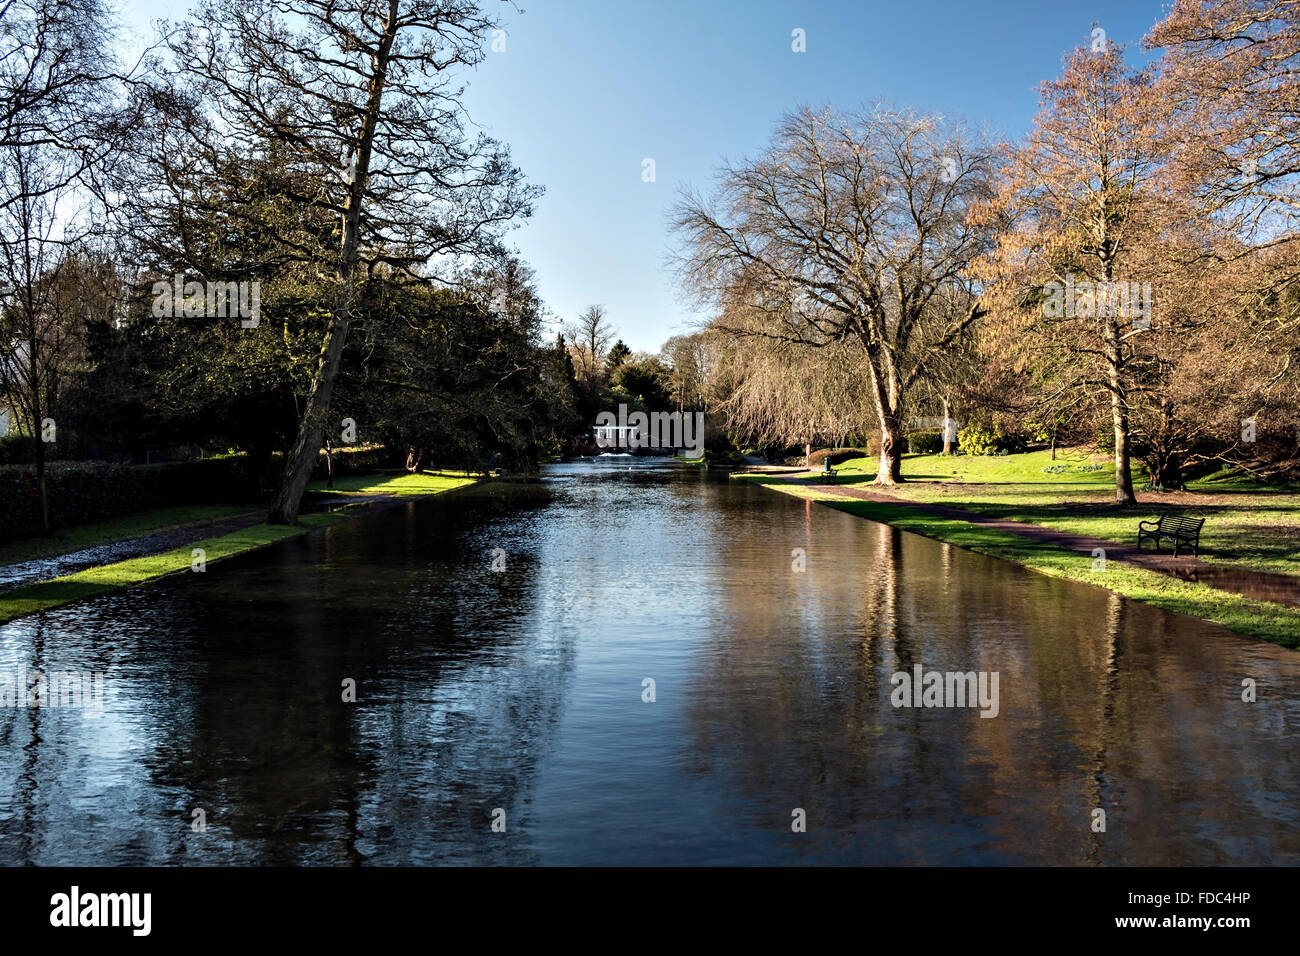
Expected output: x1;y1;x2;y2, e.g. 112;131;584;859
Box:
673;108;992;485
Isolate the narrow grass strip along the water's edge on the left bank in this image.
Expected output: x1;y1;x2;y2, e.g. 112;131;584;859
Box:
0;479;477;624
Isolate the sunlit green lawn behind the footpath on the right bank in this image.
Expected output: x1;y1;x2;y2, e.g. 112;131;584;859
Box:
807;450;1300;575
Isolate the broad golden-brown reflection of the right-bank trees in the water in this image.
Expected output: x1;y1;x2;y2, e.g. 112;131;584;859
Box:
689;503;1300;864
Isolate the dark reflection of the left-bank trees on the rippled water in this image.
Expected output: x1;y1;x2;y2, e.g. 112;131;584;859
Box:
134;486;572;865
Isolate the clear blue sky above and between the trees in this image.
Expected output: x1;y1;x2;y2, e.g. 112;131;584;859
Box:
121;0;1165;351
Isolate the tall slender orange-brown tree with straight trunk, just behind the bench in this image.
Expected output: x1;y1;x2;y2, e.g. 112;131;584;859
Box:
989;44;1165;505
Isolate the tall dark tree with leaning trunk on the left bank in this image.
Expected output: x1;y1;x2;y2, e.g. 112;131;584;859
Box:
154;0;538;523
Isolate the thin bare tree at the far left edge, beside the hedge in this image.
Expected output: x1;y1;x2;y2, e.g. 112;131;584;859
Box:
0;0;129;533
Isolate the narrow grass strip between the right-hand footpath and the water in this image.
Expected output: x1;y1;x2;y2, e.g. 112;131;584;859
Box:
732;473;1300;650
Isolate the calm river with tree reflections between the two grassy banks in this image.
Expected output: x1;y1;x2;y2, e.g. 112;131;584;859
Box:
0;458;1300;865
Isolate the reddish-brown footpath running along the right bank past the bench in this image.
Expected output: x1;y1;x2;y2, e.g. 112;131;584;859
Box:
783;479;1300;605
